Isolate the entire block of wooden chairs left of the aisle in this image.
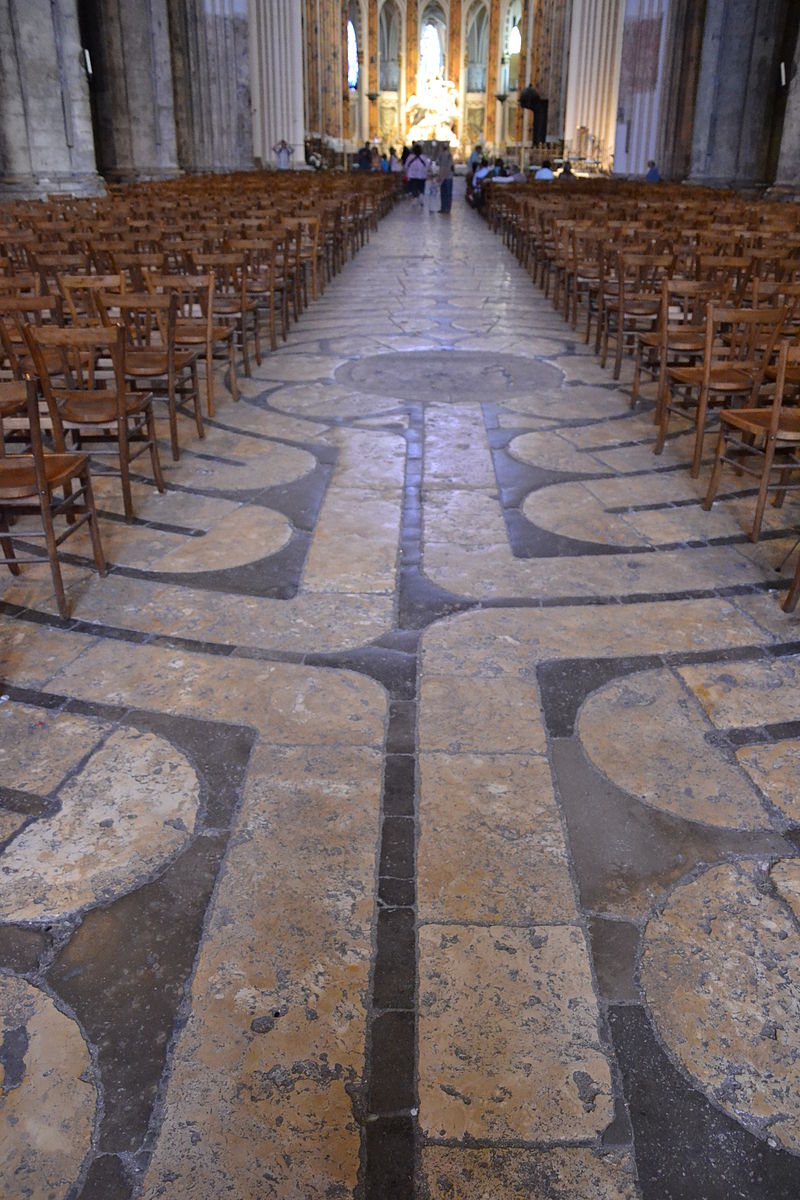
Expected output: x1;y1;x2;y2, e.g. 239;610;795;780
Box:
0;173;392;617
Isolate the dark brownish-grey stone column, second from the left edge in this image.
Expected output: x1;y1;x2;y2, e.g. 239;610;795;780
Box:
83;0;179;181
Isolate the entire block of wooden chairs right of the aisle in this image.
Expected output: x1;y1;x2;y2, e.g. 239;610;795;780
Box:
487;185;800;605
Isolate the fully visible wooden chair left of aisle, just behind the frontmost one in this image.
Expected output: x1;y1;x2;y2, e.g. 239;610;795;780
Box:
25;325;164;521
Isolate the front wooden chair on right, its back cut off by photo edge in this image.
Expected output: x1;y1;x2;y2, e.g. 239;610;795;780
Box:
703;341;800;541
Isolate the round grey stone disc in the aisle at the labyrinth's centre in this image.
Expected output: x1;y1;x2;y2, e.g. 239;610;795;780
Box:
335;350;563;403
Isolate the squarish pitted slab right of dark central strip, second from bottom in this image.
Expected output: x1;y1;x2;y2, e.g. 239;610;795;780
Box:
419;925;613;1141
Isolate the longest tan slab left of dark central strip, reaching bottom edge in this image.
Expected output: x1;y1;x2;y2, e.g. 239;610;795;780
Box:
142;746;380;1200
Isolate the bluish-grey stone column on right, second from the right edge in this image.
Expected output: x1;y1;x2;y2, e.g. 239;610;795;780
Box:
688;0;788;187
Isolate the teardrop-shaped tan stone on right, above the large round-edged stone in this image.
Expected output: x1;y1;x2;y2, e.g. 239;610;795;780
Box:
578;670;772;829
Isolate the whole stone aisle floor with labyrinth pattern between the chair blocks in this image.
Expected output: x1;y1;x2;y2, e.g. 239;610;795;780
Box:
0;187;800;1200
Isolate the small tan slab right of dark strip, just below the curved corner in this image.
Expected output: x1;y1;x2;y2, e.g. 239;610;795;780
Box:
420;674;545;754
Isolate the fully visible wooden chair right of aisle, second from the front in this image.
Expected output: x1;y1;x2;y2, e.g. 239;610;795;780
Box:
654;301;786;479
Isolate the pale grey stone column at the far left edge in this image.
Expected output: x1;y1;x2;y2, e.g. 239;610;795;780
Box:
0;0;103;197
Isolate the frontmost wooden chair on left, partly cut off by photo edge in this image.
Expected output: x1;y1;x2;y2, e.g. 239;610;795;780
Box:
0;378;106;619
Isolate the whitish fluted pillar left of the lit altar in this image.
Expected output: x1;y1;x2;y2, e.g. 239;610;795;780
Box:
248;0;305;166
